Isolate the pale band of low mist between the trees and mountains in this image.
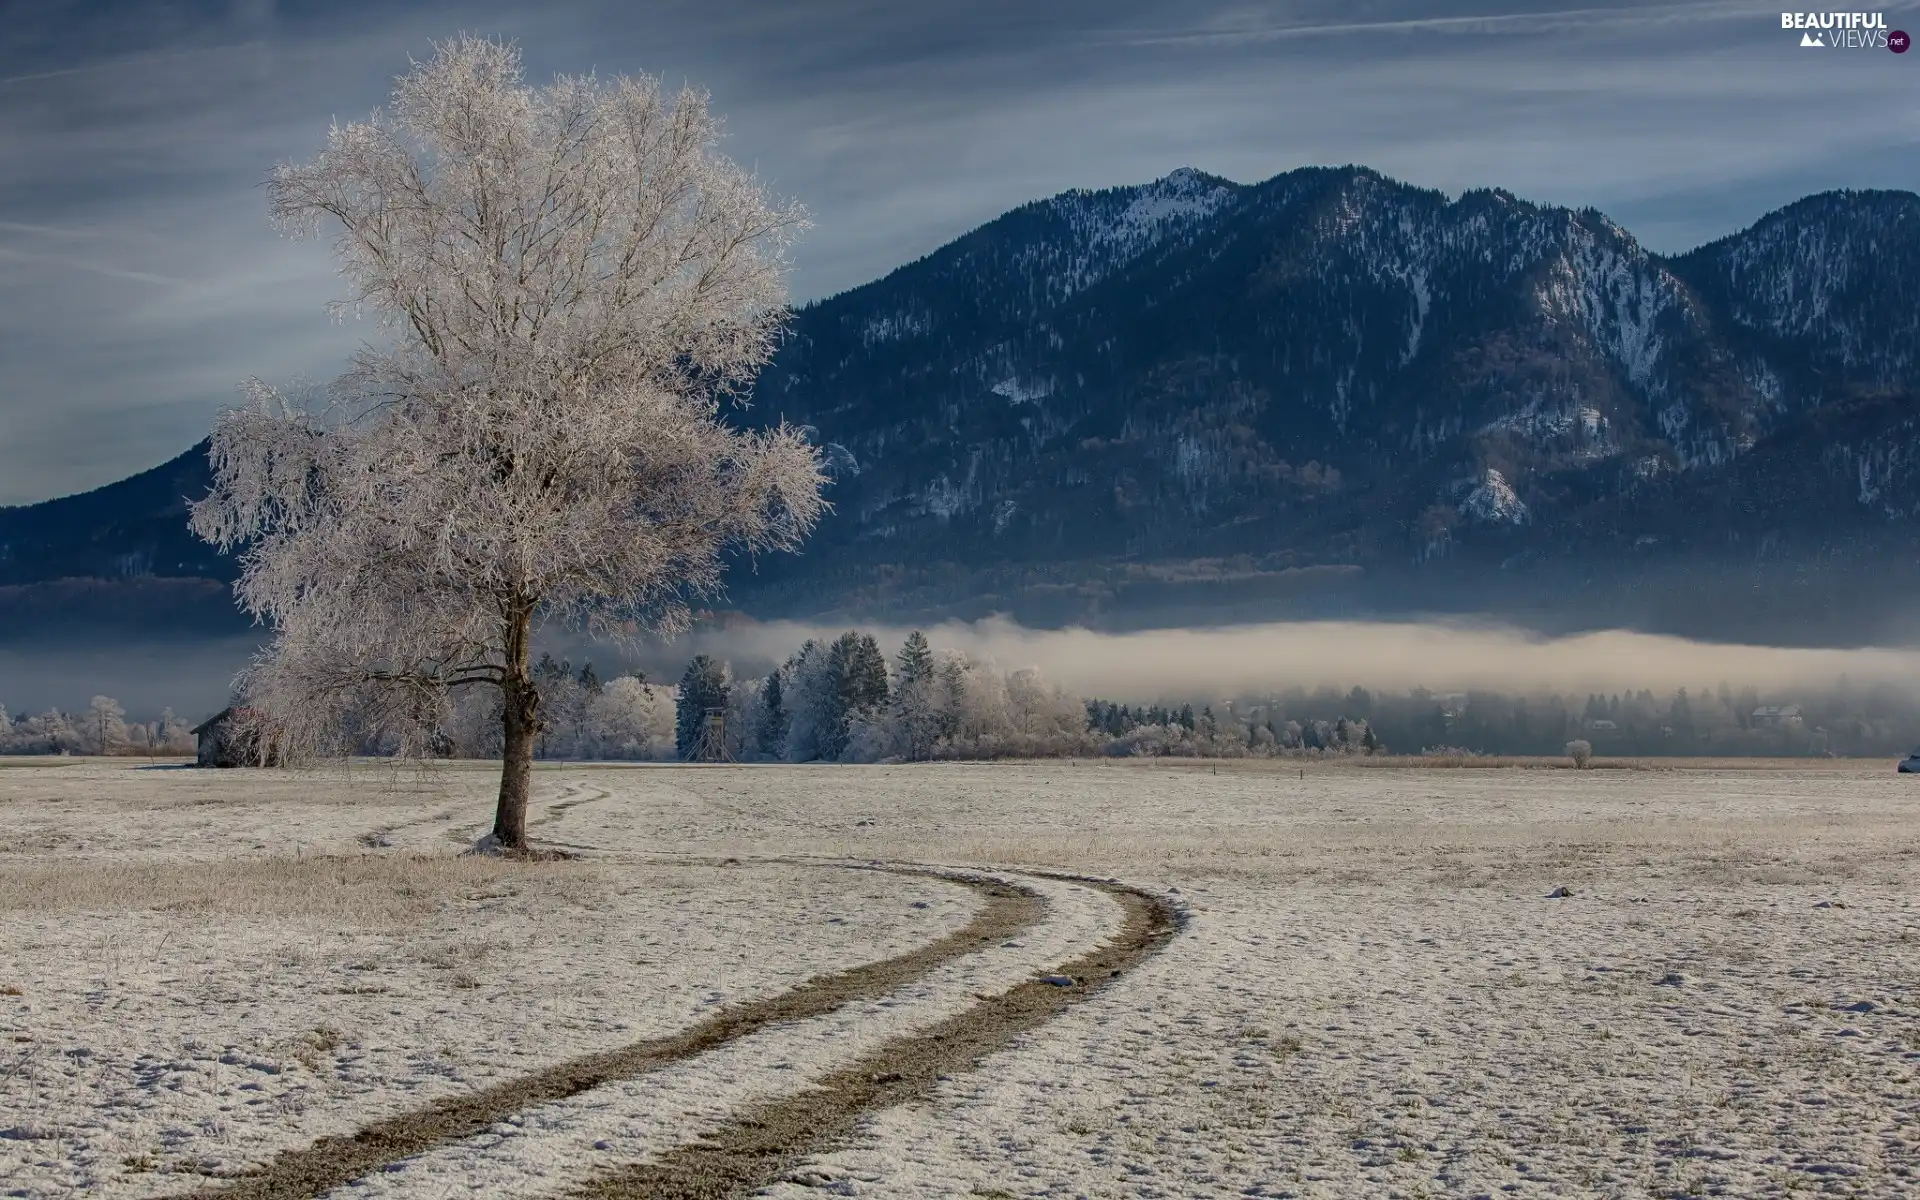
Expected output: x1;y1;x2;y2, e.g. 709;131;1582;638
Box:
0;620;1920;716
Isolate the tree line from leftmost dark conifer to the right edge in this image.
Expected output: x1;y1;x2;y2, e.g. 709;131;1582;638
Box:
652;630;1920;762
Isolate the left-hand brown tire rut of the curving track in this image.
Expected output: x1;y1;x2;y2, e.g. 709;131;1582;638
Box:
177;866;1046;1200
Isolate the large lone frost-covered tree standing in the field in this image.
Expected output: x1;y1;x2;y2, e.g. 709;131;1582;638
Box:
194;38;824;849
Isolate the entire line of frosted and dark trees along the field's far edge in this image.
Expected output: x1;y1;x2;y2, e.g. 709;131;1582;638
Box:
11;630;1920;762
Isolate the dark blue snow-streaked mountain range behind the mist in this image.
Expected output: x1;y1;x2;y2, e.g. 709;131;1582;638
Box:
0;167;1920;641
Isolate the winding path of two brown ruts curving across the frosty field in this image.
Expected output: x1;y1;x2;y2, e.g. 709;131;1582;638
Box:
177;775;1181;1200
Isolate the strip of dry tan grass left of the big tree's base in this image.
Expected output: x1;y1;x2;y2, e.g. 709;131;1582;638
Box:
0;854;603;927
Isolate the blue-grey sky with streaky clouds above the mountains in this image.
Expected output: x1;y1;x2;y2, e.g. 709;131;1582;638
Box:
0;0;1920;505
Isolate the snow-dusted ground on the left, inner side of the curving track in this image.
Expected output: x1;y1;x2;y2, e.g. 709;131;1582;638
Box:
0;762;979;1196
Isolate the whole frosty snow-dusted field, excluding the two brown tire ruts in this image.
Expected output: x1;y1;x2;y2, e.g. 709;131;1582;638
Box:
0;760;1920;1200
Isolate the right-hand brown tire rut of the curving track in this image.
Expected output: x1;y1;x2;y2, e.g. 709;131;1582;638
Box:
568;879;1181;1200
